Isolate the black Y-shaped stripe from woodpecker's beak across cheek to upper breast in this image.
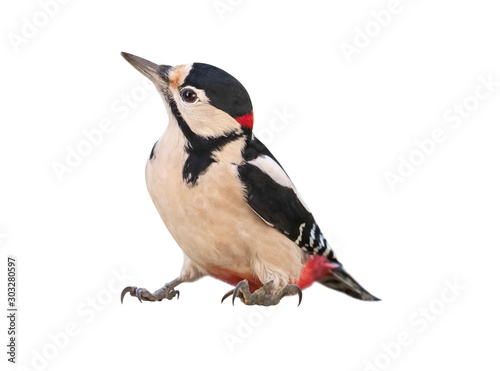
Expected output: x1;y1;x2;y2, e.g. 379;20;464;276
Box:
165;90;251;186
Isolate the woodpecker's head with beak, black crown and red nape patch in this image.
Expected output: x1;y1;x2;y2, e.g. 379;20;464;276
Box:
122;53;253;141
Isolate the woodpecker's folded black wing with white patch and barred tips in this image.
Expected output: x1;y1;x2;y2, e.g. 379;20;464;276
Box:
238;136;336;261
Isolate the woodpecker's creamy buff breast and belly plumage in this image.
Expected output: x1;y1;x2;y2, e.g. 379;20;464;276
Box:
146;122;302;287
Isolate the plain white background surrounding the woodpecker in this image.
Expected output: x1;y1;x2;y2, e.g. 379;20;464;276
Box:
0;0;500;371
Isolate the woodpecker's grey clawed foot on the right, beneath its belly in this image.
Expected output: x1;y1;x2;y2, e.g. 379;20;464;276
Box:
221;280;302;307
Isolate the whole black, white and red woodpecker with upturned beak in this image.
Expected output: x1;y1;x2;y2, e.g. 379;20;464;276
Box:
121;53;379;306
